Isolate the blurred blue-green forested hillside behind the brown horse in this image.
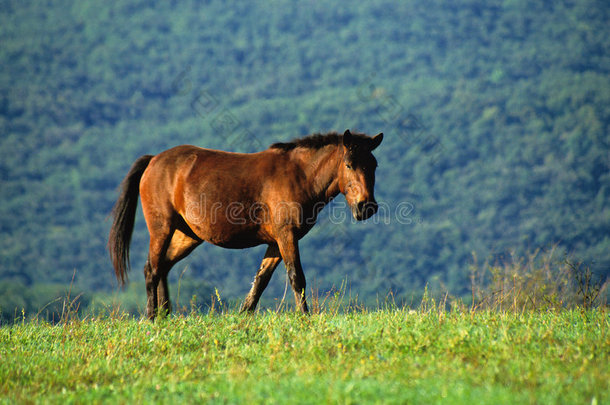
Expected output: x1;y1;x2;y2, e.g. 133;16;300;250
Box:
0;0;610;317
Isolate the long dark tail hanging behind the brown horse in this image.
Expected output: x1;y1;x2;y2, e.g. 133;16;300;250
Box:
108;155;153;285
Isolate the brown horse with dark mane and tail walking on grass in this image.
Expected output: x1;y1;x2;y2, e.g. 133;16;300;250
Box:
108;130;383;319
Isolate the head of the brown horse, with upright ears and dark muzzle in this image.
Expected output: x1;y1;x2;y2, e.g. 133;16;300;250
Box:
338;129;383;221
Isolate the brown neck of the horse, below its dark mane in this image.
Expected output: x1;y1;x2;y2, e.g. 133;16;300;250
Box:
294;145;341;203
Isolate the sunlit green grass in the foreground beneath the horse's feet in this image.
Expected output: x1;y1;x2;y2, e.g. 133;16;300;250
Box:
0;308;610;404
